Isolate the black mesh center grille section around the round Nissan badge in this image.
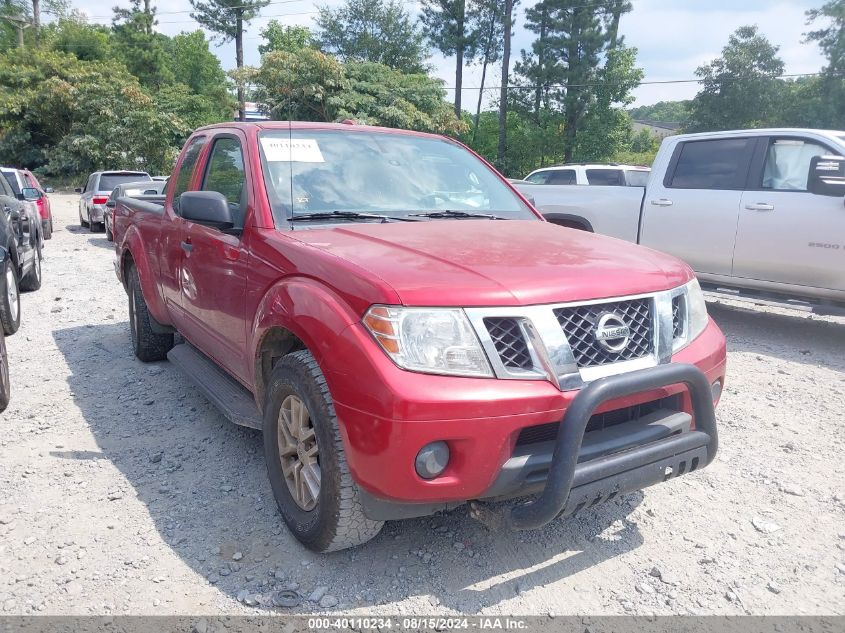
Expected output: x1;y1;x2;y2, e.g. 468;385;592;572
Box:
554;298;654;367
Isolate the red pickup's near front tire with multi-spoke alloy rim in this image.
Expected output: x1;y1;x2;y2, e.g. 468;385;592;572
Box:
264;350;384;552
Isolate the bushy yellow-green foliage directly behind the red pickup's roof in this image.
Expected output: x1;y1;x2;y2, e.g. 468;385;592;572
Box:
249;48;464;134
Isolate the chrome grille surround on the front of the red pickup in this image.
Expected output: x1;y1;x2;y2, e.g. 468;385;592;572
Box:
464;286;687;391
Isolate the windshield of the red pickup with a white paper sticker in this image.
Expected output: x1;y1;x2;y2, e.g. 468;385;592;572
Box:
260;130;537;224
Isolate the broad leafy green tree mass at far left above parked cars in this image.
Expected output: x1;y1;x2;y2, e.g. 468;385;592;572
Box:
0;50;189;175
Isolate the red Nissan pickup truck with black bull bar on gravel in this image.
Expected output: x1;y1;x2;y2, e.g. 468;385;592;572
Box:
114;122;725;551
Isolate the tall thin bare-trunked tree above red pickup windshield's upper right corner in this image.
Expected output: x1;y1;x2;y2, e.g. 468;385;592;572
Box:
420;0;476;117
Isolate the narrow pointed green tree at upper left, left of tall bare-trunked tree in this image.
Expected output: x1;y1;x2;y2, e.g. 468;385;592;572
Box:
112;0;173;88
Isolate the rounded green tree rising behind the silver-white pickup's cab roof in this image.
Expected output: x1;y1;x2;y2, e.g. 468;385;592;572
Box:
688;26;783;131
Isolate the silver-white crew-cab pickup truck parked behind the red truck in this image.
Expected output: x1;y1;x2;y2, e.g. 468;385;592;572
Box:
516;129;845;313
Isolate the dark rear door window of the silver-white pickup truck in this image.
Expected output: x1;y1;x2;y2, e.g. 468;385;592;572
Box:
666;138;751;190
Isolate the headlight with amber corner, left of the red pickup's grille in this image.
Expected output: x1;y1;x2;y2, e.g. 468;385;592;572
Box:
364;306;493;377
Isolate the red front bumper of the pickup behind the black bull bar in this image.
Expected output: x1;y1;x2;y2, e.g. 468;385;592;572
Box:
326;321;726;518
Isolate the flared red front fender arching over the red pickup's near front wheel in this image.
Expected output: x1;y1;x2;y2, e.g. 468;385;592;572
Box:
250;277;360;391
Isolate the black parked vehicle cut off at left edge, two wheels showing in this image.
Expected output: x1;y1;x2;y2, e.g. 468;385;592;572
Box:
0;172;41;334
